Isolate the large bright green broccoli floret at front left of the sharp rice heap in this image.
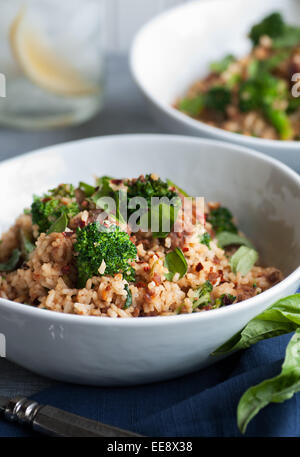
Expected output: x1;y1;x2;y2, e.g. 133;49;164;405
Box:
74;222;137;288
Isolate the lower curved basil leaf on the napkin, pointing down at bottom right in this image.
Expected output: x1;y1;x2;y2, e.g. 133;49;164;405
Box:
237;328;300;433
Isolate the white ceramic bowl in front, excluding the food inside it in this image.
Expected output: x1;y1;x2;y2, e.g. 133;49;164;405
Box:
0;135;300;385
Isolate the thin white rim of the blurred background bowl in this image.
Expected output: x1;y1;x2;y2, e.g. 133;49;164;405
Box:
129;0;300;151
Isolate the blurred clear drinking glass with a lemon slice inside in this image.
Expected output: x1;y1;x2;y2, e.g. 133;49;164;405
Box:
0;0;104;129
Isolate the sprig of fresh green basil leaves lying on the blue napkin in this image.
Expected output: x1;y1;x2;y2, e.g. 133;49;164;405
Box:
213;294;300;433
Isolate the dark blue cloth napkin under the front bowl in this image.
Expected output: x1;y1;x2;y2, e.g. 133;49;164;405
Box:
0;328;300;437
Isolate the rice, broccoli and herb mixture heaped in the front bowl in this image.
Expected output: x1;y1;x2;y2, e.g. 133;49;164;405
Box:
0;174;283;317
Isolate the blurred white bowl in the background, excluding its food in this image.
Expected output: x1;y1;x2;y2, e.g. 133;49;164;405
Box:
130;0;300;172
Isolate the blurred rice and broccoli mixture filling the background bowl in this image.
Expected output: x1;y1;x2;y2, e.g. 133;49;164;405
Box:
175;12;300;140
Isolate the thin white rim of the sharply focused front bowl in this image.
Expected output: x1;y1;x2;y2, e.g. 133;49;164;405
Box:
0;134;300;327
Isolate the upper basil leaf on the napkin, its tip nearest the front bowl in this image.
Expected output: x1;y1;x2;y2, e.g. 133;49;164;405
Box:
212;294;300;355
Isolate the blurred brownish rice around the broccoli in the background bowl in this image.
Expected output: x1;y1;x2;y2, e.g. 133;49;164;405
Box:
174;32;300;140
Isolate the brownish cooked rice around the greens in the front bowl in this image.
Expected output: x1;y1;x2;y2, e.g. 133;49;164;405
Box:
0;175;282;318
